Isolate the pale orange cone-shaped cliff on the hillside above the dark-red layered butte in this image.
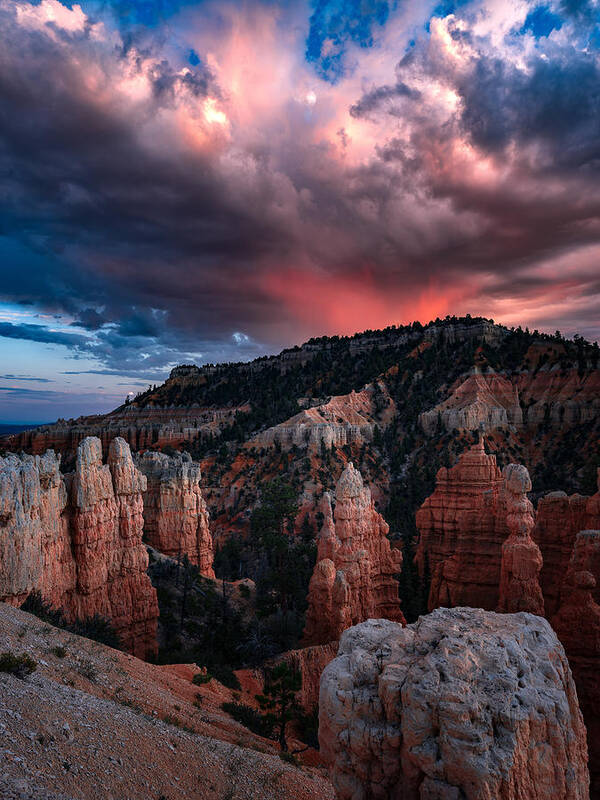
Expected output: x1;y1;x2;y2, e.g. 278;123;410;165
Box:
419;372;523;436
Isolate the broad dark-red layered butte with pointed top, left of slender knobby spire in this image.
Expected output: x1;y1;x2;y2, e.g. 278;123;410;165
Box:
415;439;509;611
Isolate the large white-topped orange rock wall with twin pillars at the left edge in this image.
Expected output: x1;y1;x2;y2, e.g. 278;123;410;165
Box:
0;438;158;656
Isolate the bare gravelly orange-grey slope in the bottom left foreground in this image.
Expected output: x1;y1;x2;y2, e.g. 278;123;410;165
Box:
0;603;334;800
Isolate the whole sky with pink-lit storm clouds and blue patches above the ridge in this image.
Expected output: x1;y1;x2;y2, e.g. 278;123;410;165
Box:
0;0;600;422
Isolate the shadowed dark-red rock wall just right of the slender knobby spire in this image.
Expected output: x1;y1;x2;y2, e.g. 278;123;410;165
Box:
532;470;600;617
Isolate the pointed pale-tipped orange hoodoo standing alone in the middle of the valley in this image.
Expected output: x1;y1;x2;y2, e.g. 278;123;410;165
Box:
304;462;404;644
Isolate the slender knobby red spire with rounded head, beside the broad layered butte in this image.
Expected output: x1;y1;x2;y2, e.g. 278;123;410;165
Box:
498;464;544;616
